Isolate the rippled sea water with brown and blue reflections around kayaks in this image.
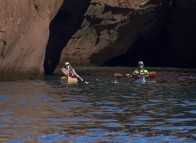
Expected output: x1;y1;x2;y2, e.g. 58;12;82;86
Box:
0;70;196;143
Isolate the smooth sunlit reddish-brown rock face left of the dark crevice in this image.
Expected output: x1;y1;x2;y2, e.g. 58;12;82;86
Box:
0;0;63;80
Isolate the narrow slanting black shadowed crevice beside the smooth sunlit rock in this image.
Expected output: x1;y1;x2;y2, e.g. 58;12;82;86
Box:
44;0;90;74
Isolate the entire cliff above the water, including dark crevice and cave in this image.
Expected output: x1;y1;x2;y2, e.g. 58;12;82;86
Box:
0;0;196;80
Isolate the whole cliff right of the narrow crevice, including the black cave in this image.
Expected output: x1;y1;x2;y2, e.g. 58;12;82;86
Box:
55;0;196;67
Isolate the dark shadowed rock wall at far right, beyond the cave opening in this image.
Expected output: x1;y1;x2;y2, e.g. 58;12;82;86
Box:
167;0;196;68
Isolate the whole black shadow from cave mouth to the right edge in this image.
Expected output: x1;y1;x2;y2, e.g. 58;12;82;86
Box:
104;0;196;68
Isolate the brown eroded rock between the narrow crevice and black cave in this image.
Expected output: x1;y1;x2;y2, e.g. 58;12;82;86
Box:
57;0;169;65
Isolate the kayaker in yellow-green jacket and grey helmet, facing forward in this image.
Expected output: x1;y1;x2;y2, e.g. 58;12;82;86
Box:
126;61;149;78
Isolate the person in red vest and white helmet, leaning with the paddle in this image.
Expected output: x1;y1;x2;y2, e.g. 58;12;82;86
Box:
61;62;84;81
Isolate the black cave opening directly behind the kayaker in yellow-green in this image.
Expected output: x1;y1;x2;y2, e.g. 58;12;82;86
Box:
104;28;171;67
